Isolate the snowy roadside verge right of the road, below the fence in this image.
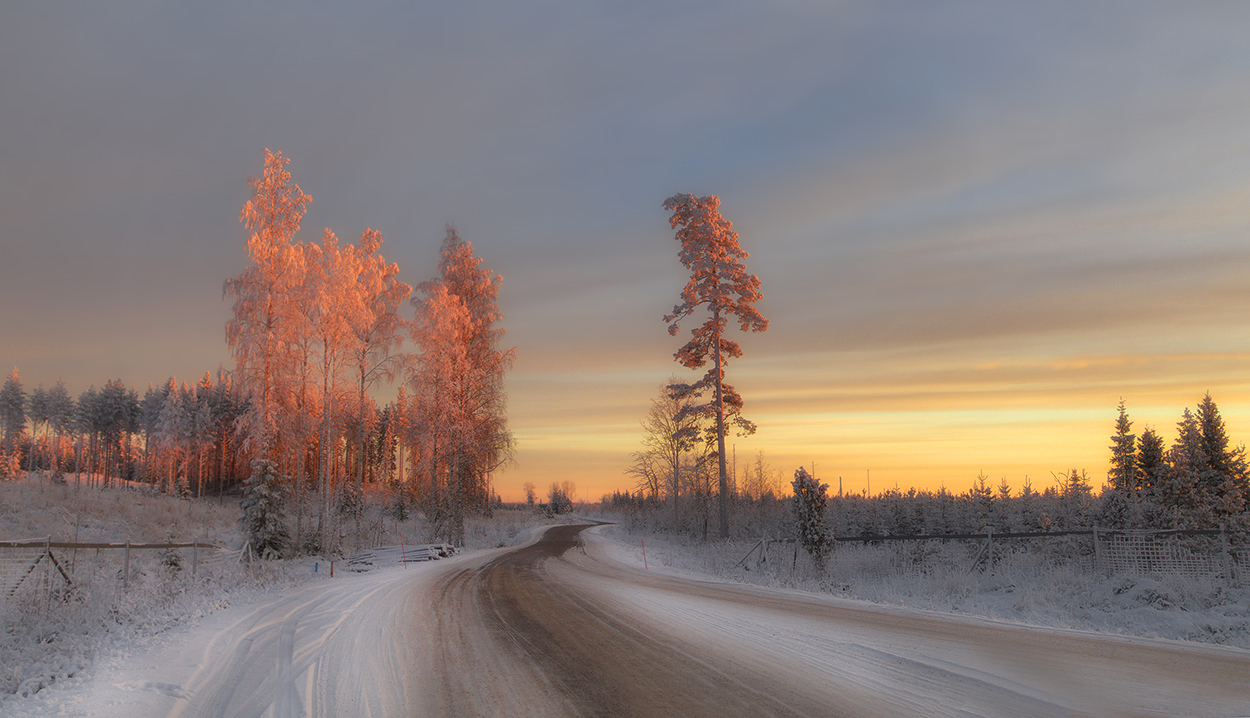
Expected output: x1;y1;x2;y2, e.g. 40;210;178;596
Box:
591;525;1250;649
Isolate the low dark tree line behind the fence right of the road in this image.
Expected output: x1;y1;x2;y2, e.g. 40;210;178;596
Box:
622;379;1250;540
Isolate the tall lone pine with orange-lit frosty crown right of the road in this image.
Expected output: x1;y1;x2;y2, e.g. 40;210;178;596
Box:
664;194;769;538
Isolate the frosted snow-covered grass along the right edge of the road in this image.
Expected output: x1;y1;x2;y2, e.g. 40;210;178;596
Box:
600;517;1250;649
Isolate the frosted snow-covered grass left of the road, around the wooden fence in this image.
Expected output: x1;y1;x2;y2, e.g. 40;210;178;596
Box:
0;474;559;714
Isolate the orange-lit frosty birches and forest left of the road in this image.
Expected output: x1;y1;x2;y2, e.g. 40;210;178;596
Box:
0;150;514;550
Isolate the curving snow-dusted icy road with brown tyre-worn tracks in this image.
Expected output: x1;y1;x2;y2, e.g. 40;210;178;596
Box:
65;525;1250;718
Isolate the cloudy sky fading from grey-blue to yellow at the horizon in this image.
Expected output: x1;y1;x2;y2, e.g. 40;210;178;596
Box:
0;0;1250;499
